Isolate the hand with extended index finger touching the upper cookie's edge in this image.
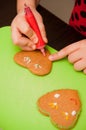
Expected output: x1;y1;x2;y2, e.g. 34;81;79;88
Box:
49;40;86;74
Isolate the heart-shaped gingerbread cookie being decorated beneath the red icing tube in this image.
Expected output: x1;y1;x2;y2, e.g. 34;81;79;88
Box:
14;50;52;75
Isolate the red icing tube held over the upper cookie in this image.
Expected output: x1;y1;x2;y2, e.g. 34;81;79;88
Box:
25;5;45;55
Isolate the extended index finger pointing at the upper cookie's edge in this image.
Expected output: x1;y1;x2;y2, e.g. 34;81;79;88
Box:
49;43;79;61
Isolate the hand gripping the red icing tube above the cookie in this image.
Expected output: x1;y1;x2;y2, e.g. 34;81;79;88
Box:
11;9;47;51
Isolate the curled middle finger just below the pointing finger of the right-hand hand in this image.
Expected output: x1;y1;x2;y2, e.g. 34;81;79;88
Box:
68;50;82;63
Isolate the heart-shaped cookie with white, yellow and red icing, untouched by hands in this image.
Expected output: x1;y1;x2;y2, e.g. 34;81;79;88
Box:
37;89;81;130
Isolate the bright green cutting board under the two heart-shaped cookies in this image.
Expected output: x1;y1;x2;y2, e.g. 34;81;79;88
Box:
0;26;86;130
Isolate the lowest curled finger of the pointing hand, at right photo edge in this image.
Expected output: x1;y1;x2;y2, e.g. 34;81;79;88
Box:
74;59;86;71
